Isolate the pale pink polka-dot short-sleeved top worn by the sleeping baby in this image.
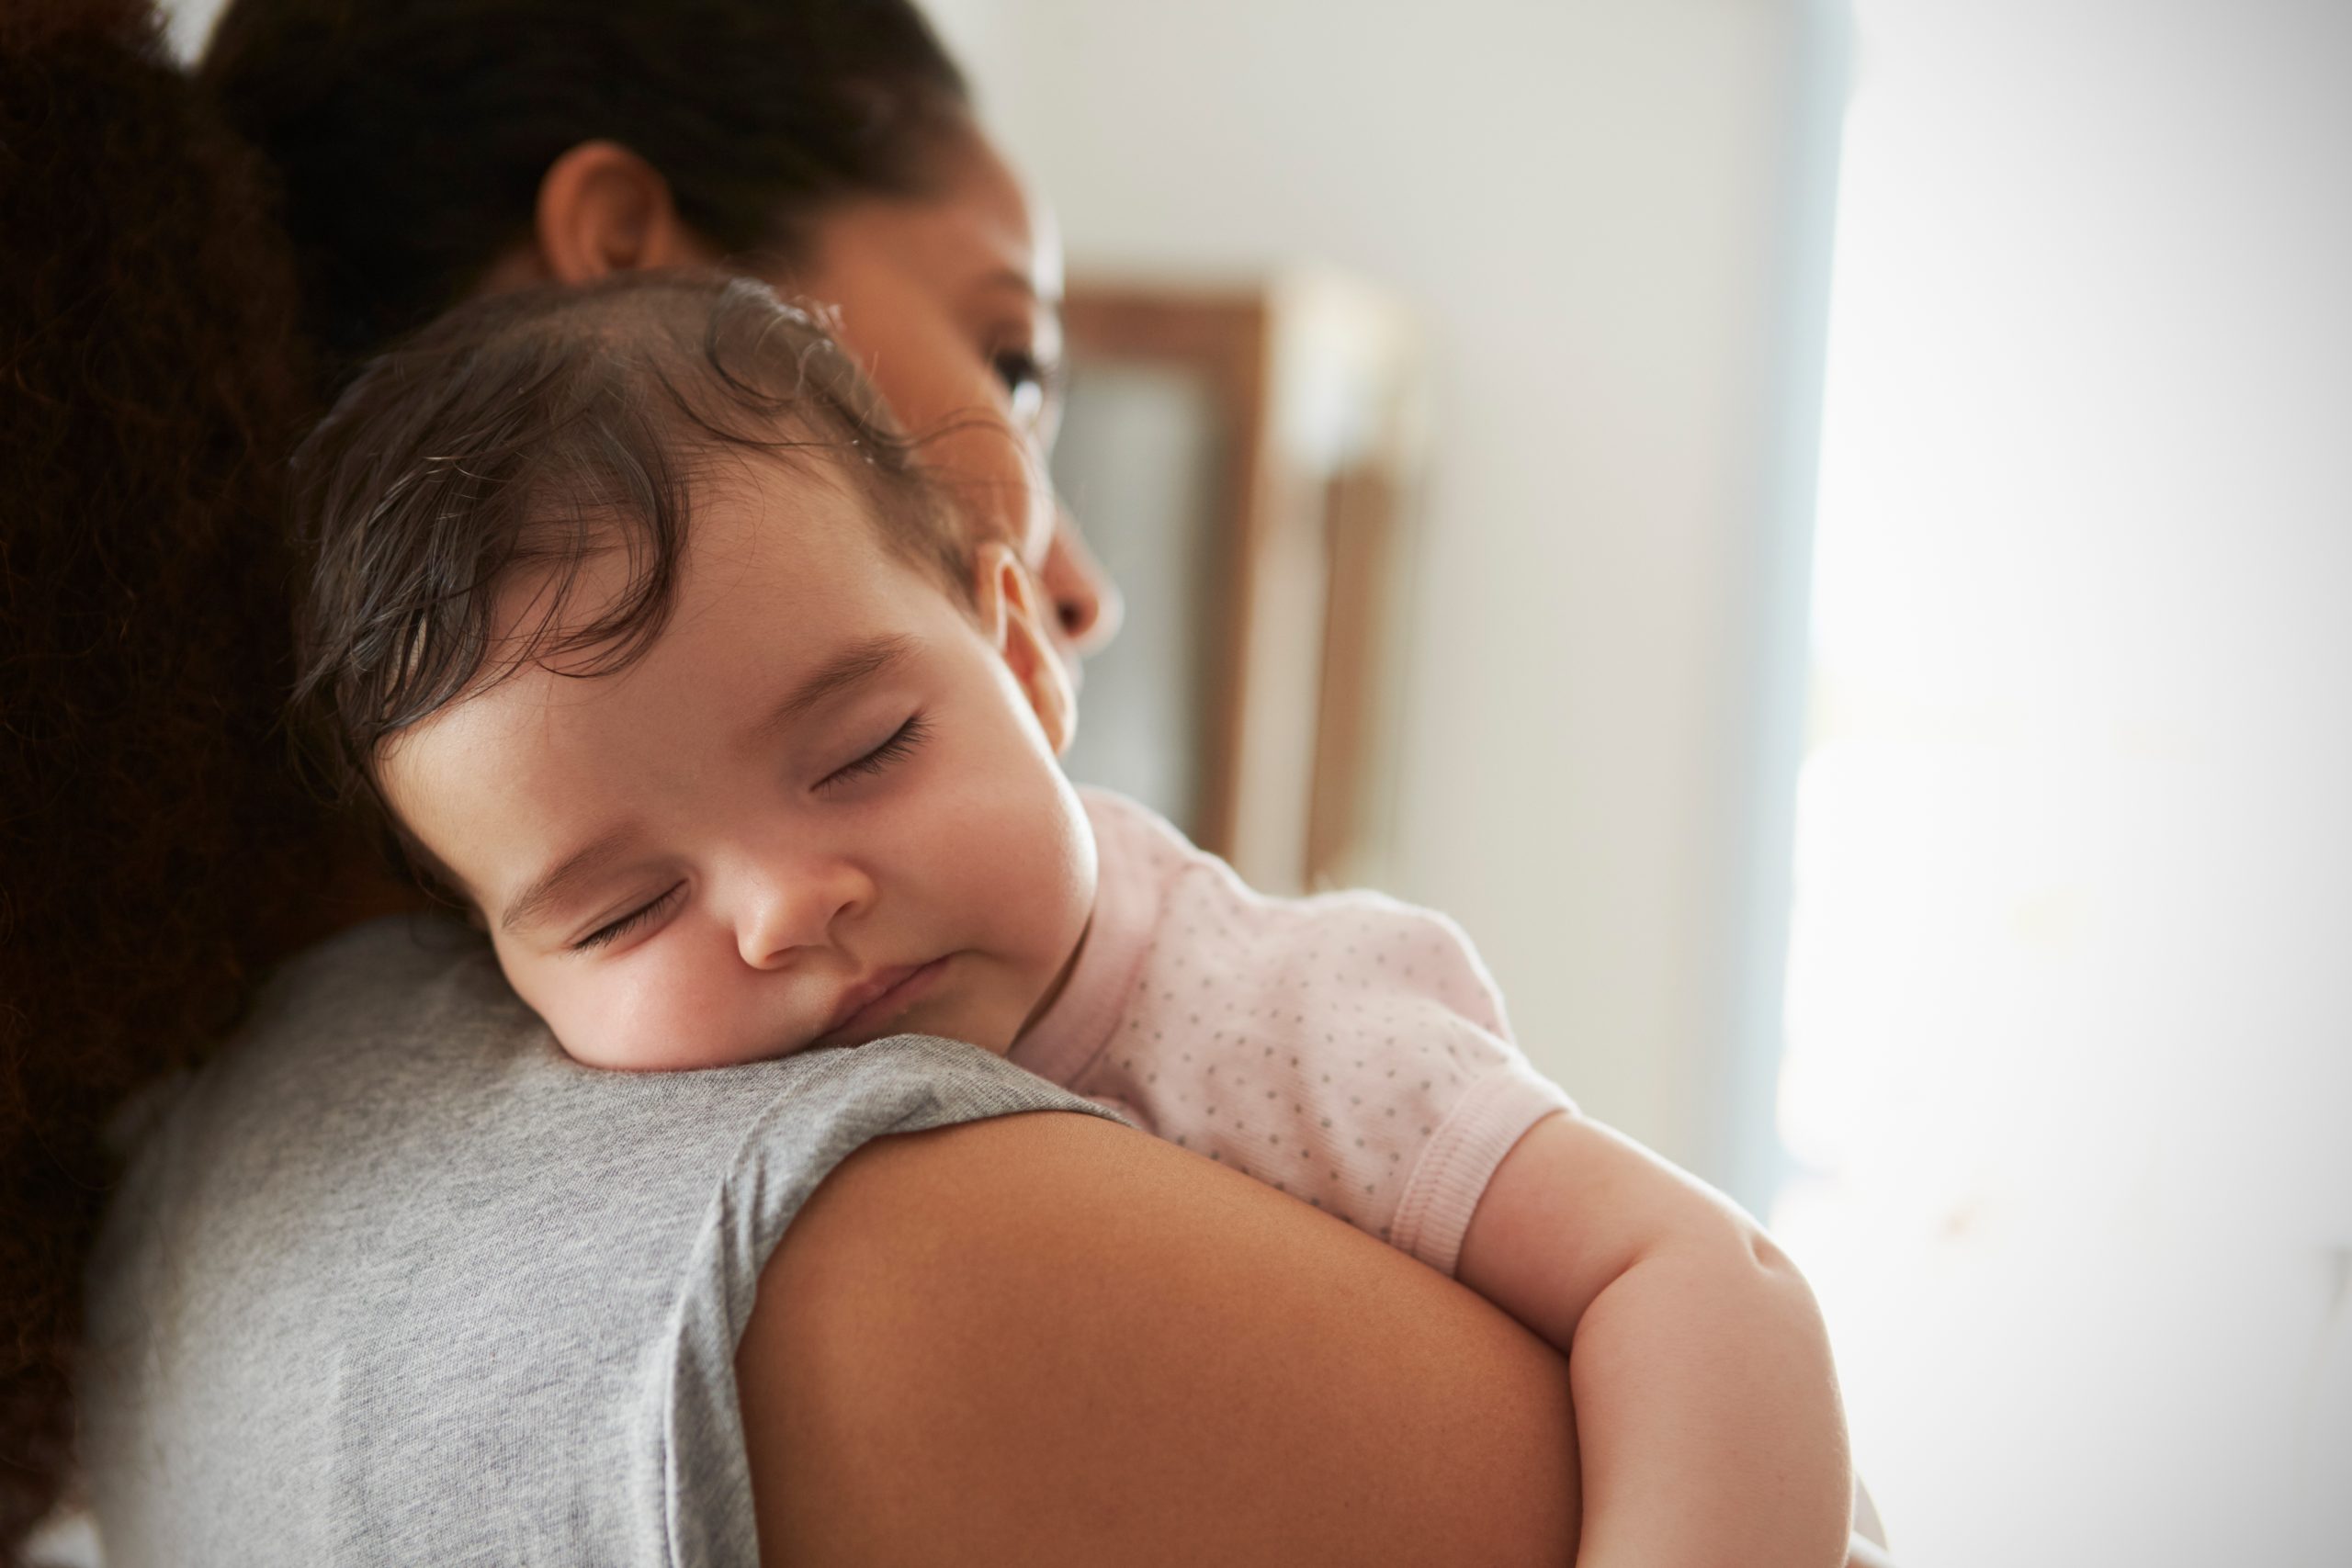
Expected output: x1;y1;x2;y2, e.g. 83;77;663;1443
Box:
1012;790;1569;1274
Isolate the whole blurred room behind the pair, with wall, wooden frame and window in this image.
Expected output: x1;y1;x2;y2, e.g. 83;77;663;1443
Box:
165;0;2352;1568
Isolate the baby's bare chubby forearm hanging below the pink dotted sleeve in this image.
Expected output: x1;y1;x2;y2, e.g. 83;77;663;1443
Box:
1456;1114;1853;1568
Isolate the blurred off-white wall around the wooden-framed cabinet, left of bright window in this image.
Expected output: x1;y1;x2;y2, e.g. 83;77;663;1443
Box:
933;0;1804;1168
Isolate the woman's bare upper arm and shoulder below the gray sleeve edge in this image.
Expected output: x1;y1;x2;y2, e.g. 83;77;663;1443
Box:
736;1114;1578;1568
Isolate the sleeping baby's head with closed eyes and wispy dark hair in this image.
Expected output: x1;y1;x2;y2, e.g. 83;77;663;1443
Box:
297;277;1093;1069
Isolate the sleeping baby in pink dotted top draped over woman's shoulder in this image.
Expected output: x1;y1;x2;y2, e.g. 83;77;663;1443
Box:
299;275;1849;1568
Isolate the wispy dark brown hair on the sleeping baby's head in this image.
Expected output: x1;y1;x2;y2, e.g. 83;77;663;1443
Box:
294;273;971;894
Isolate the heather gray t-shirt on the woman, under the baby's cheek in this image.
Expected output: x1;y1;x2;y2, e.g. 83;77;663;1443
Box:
80;919;1101;1568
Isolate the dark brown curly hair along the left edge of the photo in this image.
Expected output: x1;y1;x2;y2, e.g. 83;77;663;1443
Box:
0;0;341;1561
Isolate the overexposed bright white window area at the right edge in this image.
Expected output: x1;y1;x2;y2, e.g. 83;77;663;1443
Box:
1773;0;2352;1568
